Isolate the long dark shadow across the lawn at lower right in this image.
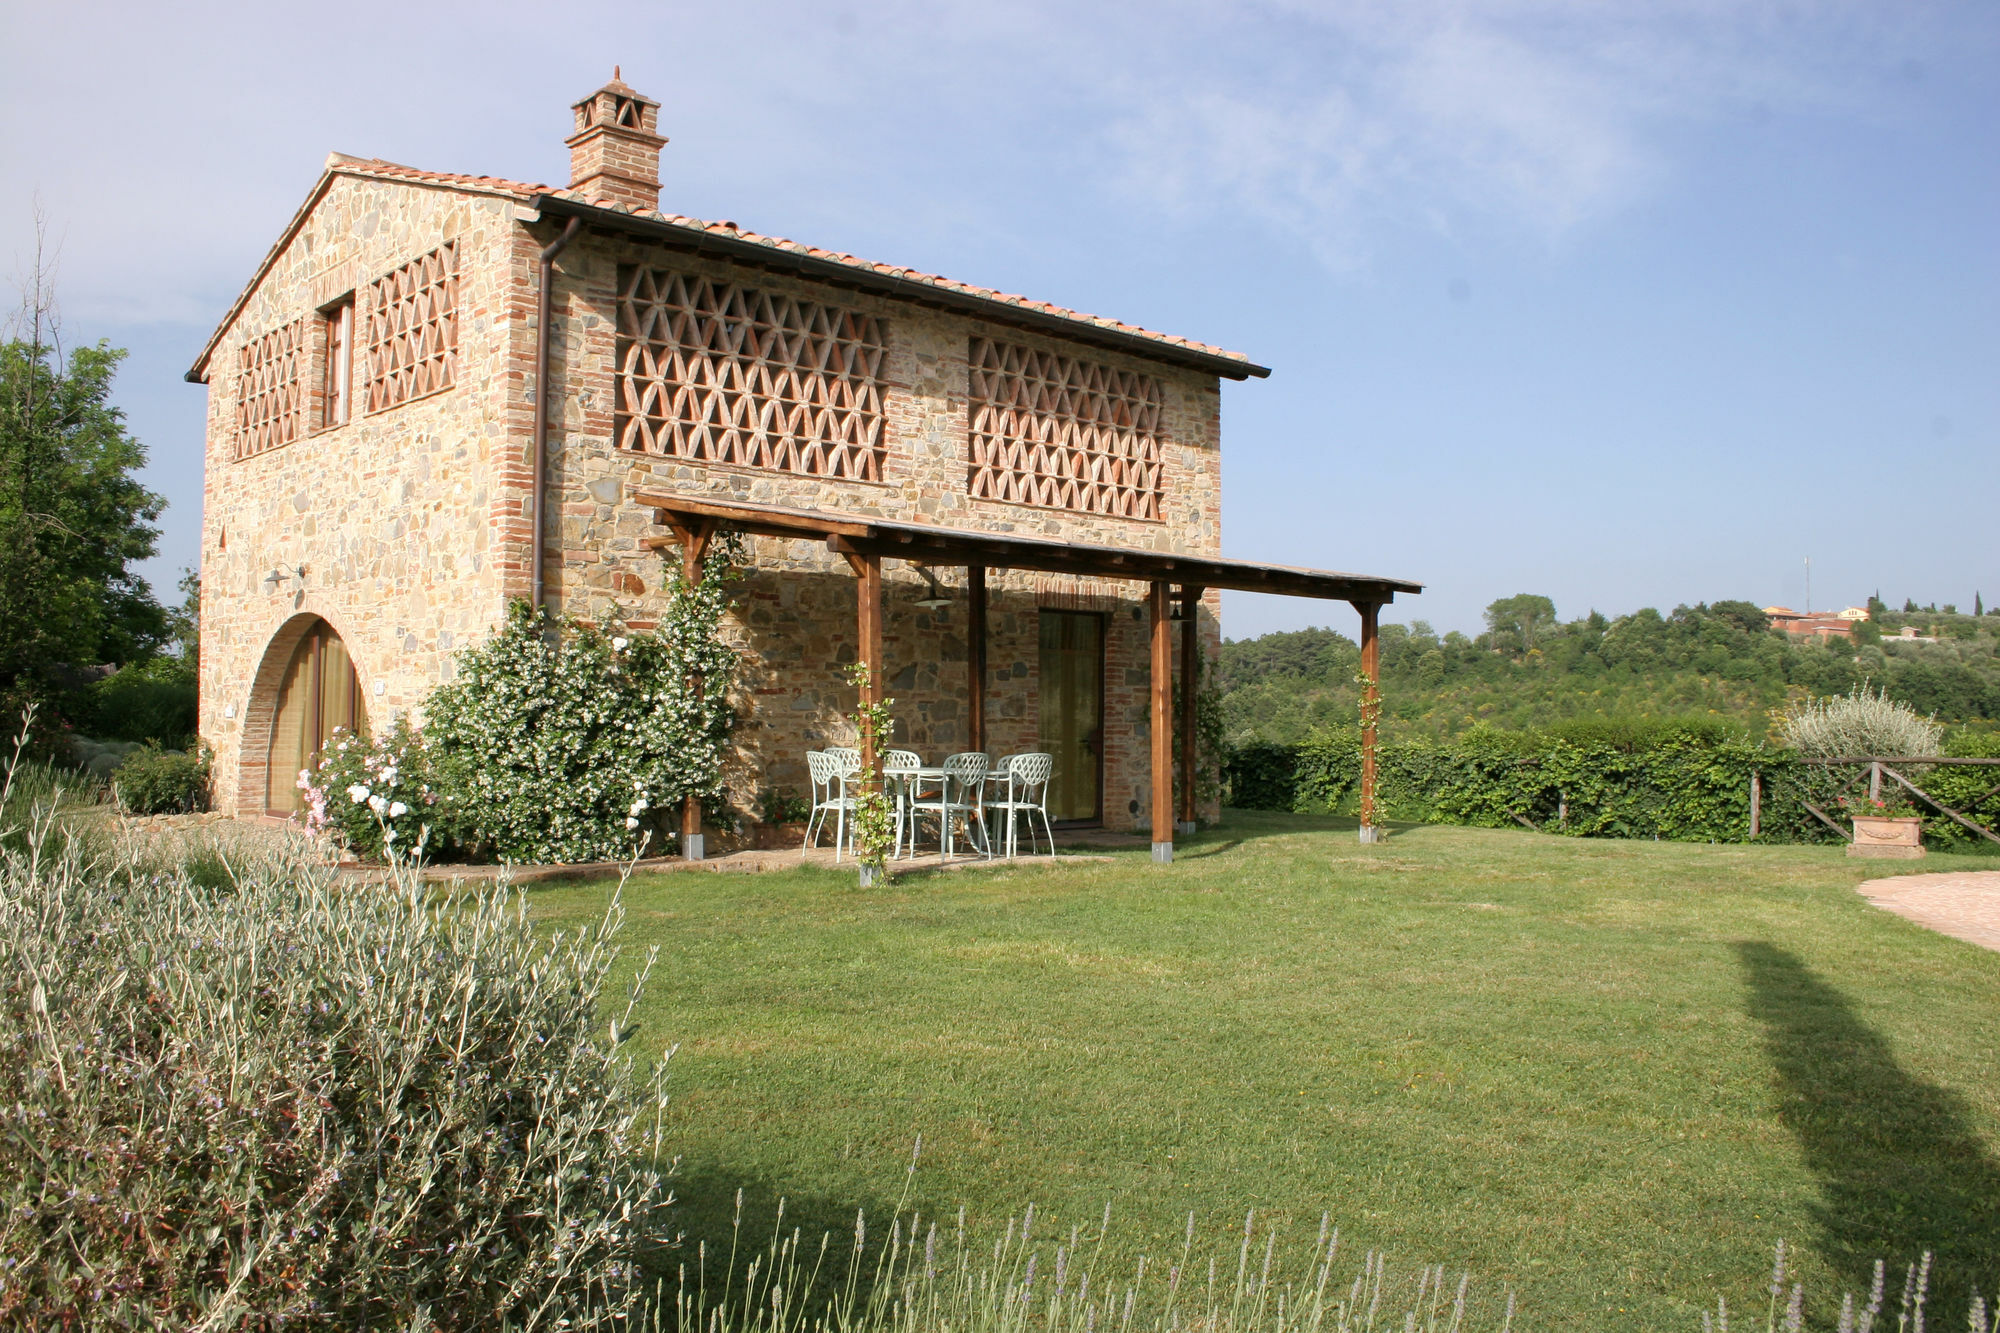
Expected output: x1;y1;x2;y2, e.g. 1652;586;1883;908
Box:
1736;943;2000;1321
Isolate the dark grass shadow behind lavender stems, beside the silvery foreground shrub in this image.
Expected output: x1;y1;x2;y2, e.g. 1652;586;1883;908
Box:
634;1165;896;1327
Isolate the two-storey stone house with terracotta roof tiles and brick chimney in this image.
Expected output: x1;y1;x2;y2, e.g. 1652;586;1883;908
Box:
188;76;1416;852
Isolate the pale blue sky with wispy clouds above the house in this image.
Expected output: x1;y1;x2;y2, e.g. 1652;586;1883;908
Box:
0;0;2000;636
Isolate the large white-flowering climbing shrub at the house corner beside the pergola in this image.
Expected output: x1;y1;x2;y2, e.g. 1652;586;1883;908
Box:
424;558;736;861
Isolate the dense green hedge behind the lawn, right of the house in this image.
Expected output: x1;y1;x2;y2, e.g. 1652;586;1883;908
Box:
1228;727;1834;843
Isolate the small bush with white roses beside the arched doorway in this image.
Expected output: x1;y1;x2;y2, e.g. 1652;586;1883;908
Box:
298;719;454;859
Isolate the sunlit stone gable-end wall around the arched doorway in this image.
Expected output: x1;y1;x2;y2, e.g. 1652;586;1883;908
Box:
200;176;532;813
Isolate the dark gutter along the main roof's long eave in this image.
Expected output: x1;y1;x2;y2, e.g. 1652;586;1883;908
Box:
536;194;1270;380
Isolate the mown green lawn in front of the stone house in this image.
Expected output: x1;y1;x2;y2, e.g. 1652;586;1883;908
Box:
532;811;2000;1329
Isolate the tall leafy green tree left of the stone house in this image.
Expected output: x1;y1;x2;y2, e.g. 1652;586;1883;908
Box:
0;239;166;716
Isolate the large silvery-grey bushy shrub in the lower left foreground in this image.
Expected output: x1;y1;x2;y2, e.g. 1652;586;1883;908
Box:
0;764;666;1329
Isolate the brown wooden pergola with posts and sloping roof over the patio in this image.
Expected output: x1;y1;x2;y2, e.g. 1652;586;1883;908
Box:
632;490;1424;863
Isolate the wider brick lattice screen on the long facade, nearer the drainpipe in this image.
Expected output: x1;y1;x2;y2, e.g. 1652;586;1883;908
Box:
616;268;884;480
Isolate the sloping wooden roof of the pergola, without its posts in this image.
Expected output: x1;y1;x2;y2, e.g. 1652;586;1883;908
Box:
632;490;1424;602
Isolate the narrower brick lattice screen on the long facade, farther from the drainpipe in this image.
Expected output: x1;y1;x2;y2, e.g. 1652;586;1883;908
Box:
966;338;1164;518
